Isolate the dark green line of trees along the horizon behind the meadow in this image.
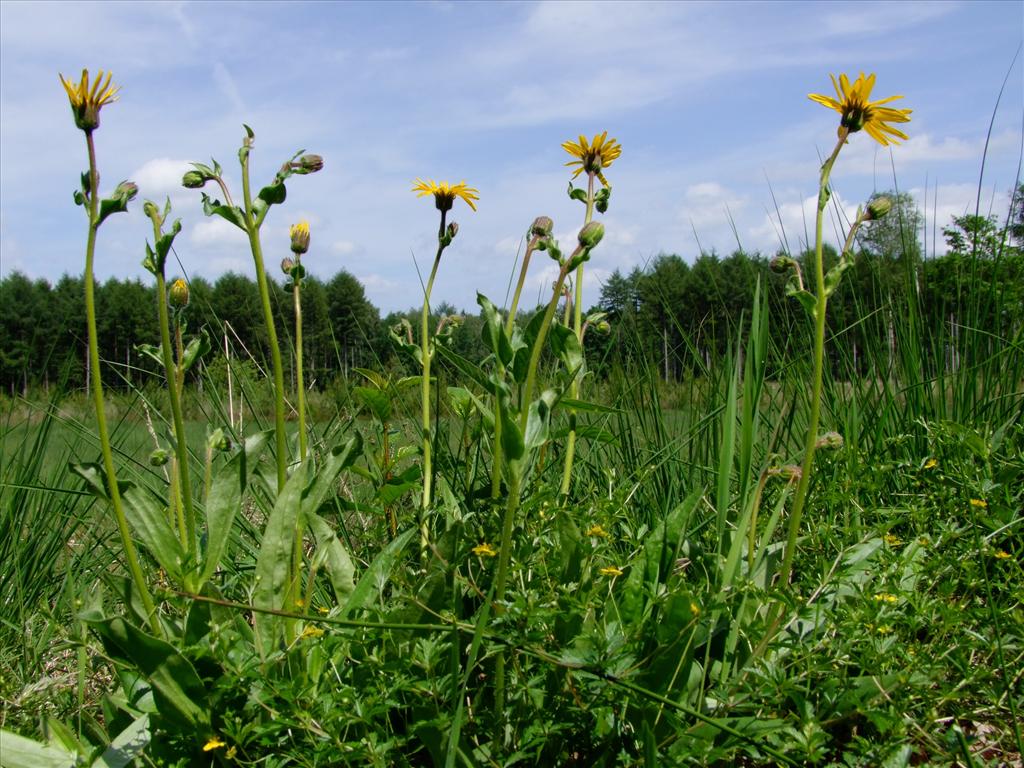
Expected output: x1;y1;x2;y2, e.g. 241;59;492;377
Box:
0;191;1024;395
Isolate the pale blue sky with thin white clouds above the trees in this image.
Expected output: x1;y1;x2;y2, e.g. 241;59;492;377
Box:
0;0;1024;311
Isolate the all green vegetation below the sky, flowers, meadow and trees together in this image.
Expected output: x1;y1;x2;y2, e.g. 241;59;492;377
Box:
0;70;1024;768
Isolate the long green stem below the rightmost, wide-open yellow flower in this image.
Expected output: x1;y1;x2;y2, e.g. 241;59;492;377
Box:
778;130;847;589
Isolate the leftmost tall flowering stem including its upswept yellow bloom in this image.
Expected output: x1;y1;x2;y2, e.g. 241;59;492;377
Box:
60;72;164;637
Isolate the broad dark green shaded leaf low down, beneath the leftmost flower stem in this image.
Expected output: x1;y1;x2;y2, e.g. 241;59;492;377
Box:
79;612;210;731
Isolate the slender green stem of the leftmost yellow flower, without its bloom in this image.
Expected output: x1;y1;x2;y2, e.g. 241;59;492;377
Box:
85;131;164;638
